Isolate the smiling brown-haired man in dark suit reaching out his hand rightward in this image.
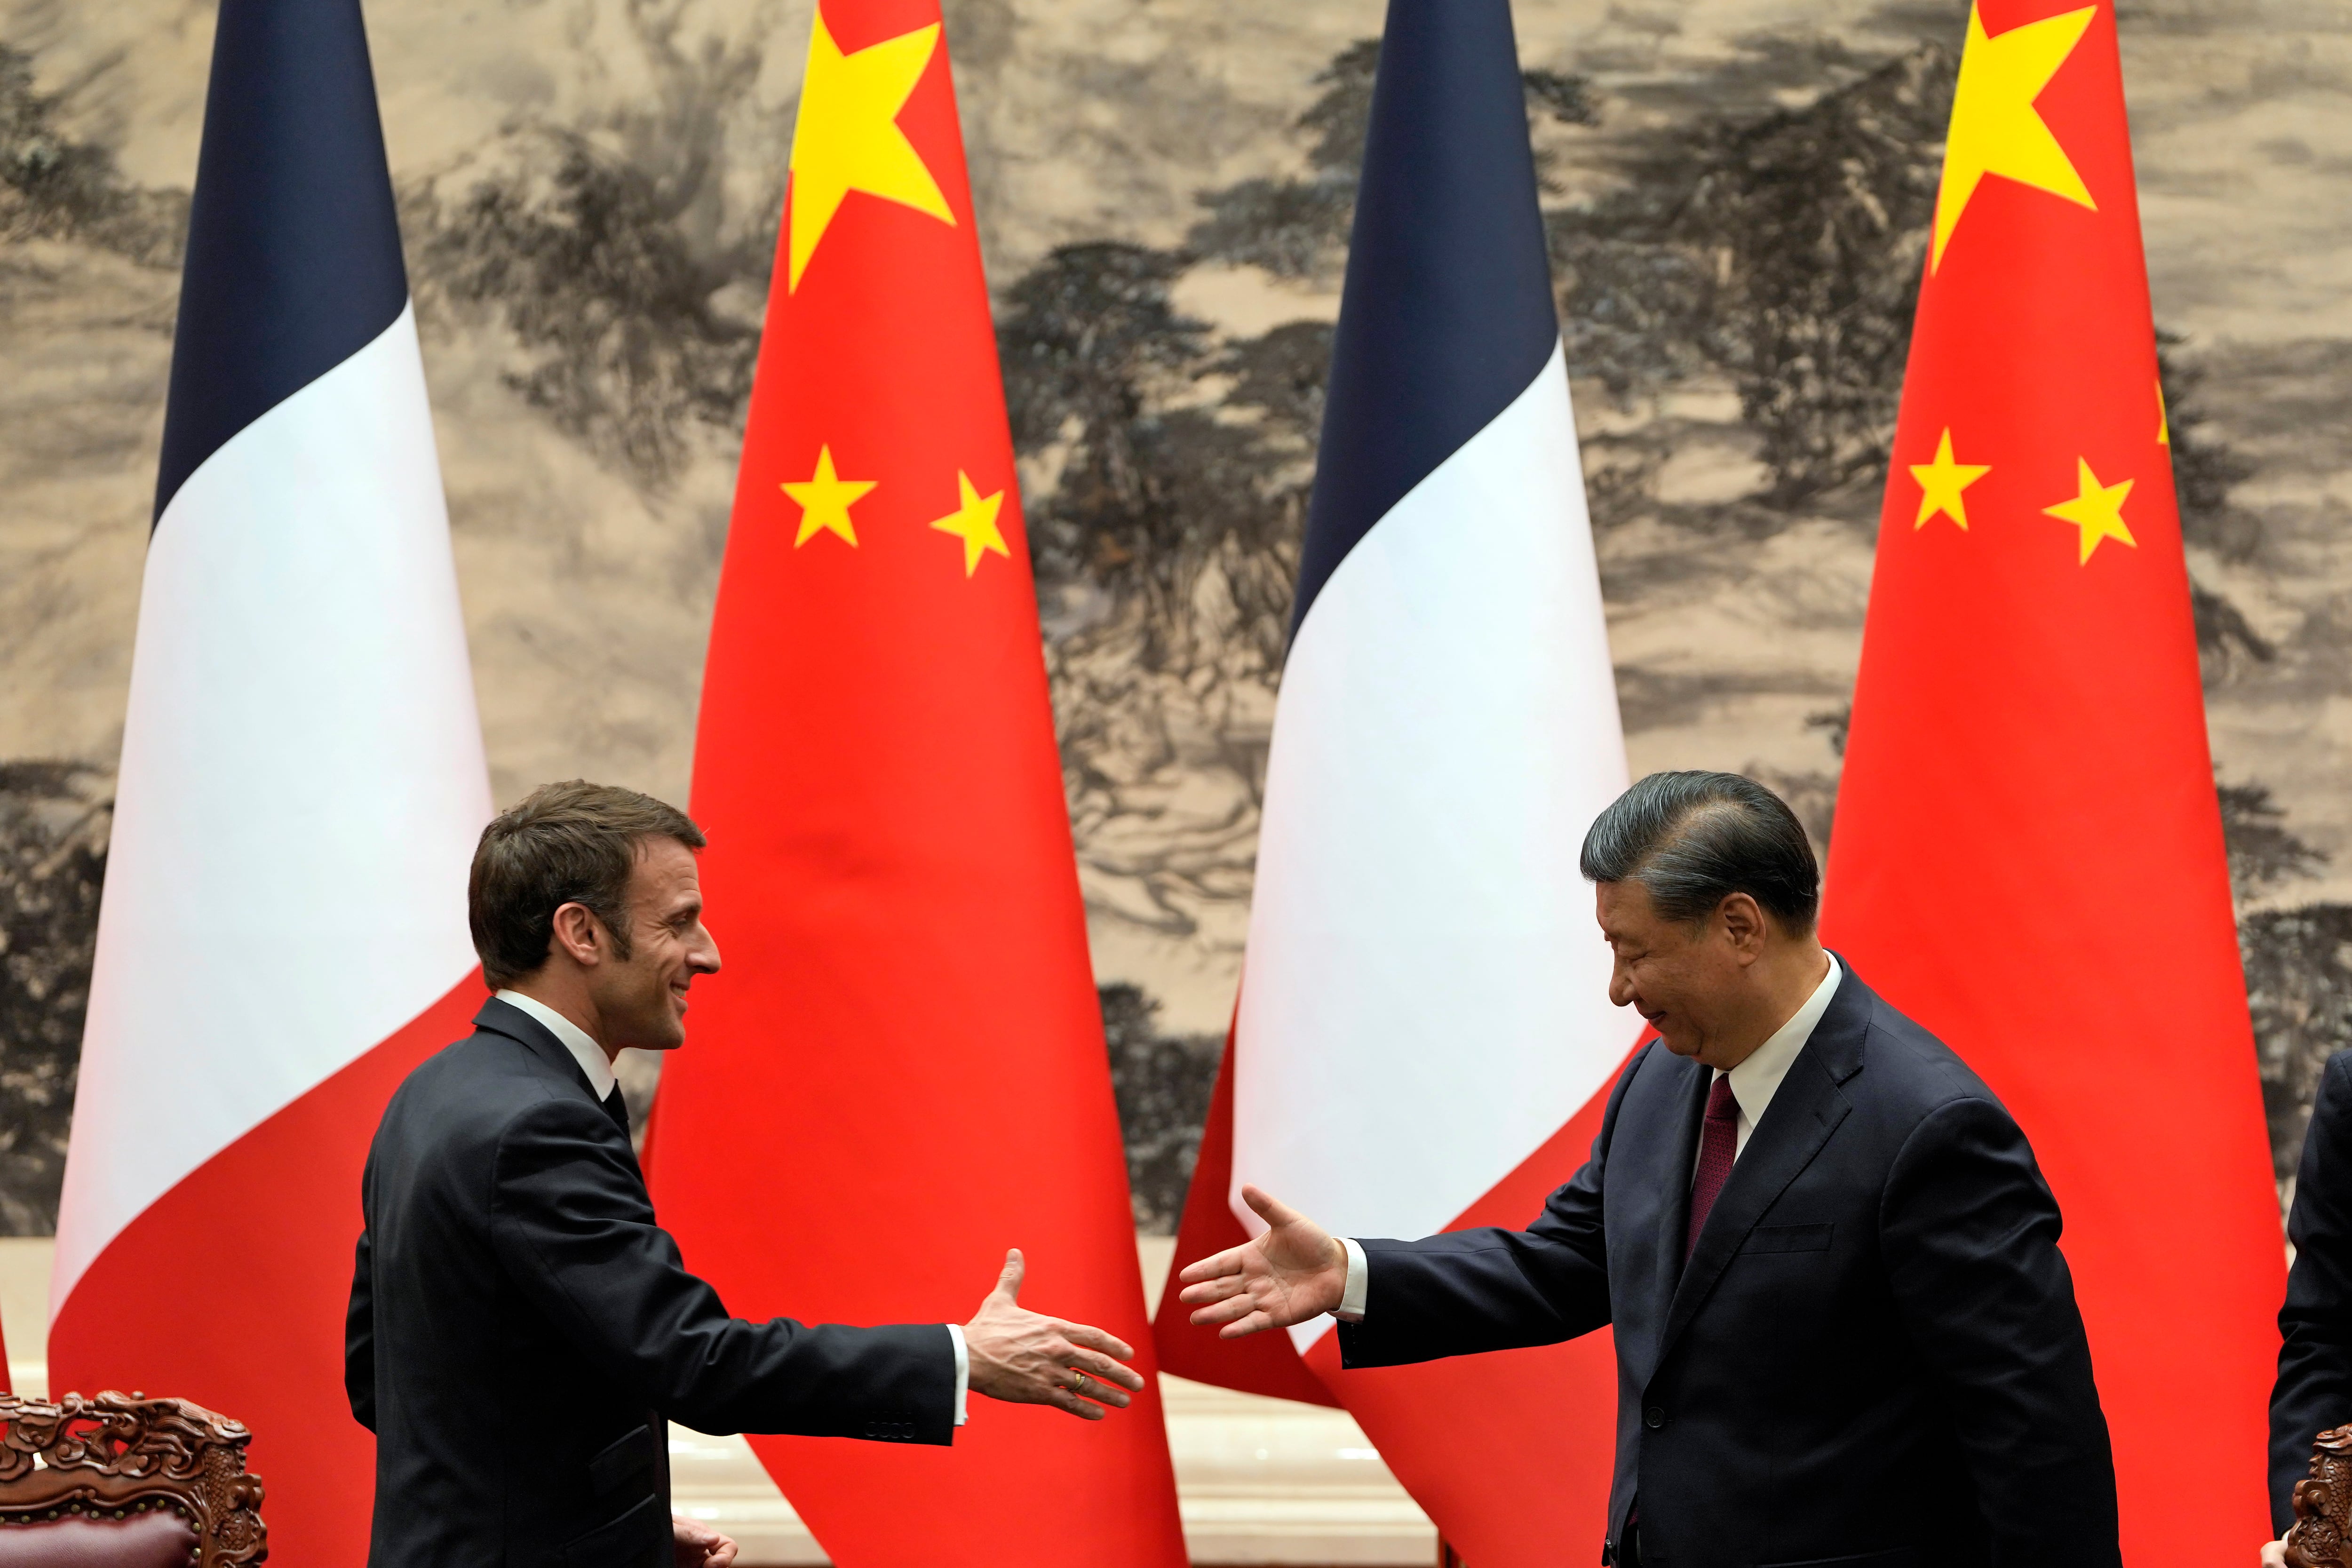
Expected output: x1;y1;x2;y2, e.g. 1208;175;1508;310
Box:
346;780;1143;1568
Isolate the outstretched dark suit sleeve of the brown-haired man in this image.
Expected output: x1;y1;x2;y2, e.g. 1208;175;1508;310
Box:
492;1100;955;1443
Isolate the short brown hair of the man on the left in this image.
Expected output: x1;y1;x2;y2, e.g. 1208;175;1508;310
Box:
466;778;706;990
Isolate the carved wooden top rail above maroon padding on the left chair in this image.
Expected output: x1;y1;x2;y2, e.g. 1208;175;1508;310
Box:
0;1392;268;1568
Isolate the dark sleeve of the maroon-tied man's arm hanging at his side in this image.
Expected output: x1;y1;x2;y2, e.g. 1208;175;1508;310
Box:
1879;1098;2122;1568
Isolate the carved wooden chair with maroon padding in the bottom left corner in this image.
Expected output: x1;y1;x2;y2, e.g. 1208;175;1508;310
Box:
0;1394;268;1568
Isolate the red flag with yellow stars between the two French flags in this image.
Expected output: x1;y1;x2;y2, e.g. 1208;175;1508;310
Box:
649;0;1185;1568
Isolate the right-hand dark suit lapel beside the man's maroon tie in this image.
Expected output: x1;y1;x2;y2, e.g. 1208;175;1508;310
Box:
1658;959;1870;1361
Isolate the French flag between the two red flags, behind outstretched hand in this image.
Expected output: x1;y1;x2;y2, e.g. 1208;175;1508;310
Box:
1155;0;1639;1568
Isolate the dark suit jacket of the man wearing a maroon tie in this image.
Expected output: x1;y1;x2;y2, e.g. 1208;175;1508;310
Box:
1338;969;2122;1568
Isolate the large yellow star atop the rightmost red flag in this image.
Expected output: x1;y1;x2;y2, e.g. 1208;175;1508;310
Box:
1926;5;2098;273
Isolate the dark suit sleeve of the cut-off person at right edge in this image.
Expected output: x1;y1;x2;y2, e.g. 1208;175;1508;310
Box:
2270;1051;2352;1535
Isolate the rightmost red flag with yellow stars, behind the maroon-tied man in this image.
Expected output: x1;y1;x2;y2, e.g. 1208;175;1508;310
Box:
1825;0;2286;1568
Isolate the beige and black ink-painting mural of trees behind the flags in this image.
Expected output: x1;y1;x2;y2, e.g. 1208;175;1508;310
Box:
0;0;2352;1234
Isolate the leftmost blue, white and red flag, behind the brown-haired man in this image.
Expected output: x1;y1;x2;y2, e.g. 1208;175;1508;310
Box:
49;0;489;1566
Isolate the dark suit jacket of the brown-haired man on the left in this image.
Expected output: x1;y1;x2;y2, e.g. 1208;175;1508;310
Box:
343;999;955;1568
